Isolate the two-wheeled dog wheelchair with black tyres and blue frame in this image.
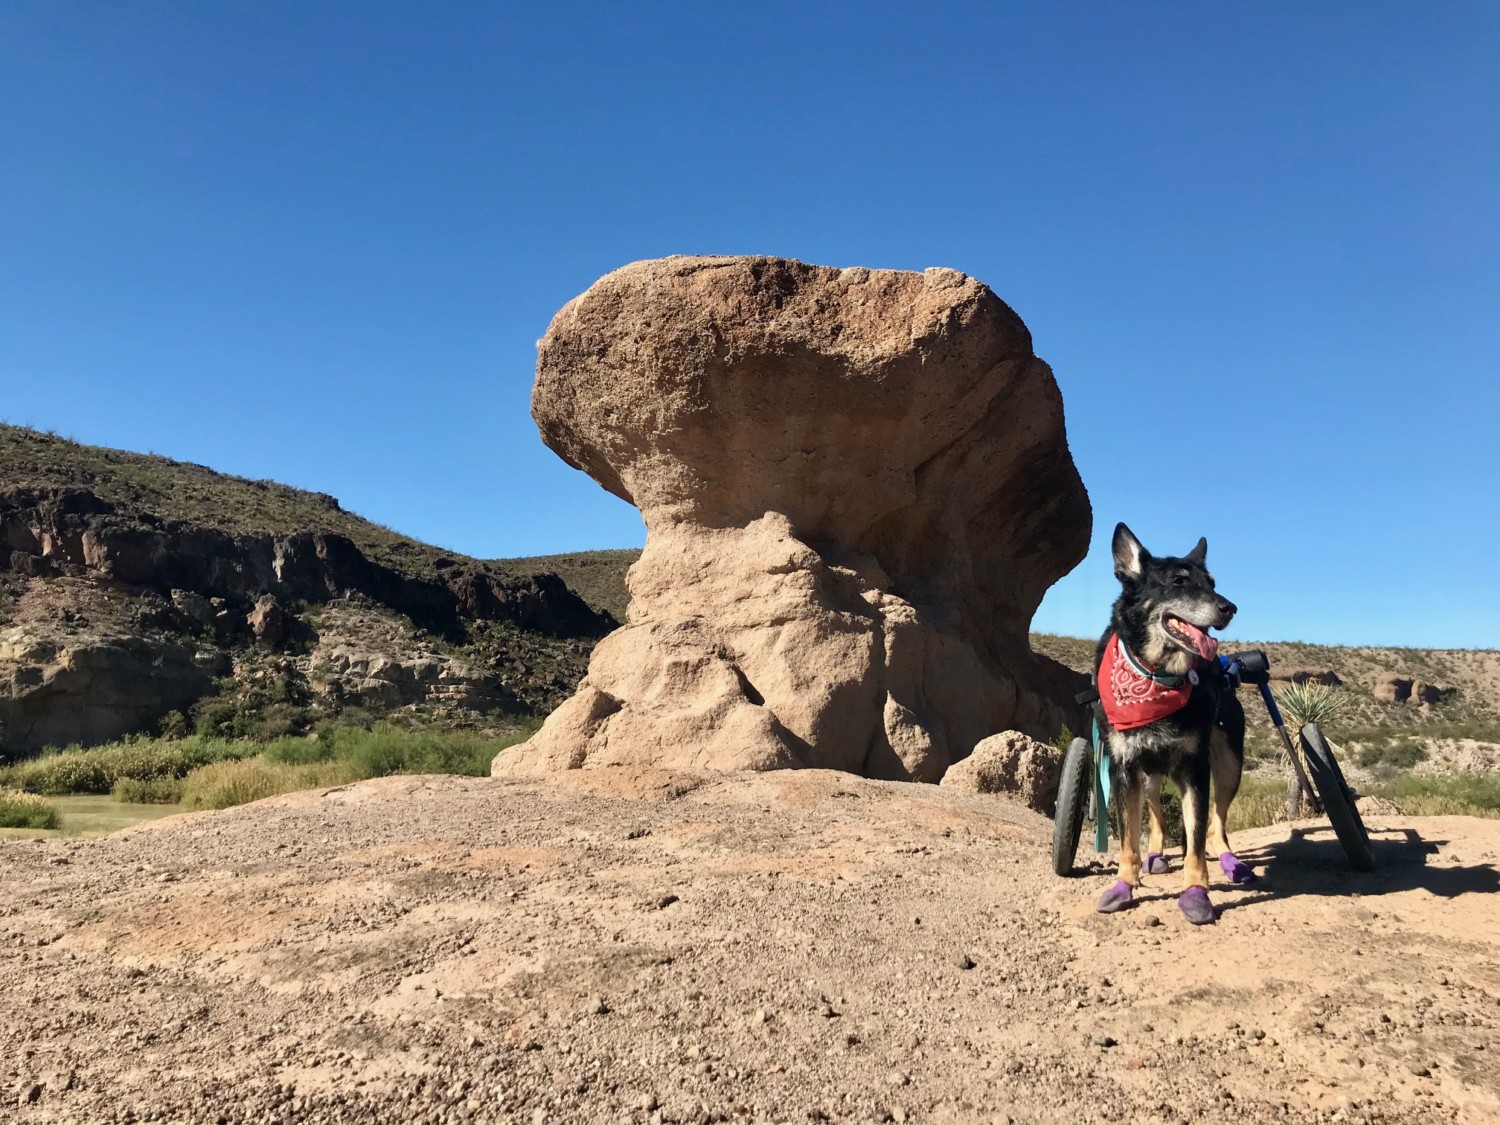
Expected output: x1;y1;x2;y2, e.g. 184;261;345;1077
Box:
1052;650;1376;875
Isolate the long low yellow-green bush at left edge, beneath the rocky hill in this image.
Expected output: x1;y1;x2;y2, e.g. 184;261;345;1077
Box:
0;738;257;794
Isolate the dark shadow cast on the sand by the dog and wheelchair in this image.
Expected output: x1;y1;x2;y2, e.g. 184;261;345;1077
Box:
1220;825;1500;914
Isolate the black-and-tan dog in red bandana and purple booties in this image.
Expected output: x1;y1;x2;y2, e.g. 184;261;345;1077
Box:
1094;524;1256;926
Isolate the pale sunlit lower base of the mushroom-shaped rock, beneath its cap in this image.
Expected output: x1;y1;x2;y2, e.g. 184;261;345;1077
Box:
495;513;1073;782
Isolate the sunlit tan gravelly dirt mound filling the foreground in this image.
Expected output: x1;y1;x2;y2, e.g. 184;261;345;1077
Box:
0;770;1500;1125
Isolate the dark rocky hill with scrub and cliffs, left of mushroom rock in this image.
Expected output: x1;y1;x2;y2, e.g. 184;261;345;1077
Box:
0;426;615;756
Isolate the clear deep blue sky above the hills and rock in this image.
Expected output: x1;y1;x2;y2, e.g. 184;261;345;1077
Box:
0;0;1500;647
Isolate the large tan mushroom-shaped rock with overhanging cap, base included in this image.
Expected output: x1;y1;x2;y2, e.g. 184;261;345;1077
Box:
494;257;1092;782
